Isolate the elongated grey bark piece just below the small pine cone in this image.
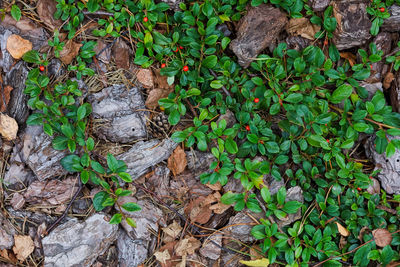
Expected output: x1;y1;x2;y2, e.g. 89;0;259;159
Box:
116;139;178;179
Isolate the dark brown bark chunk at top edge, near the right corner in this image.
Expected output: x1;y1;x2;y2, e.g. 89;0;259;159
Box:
332;0;371;50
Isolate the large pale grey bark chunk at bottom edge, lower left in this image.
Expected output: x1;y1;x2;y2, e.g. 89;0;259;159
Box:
42;213;118;267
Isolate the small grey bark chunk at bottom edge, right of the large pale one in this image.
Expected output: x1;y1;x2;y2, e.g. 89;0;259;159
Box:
117;230;148;267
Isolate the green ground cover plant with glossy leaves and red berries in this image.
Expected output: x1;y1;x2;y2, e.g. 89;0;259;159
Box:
2;0;400;266
